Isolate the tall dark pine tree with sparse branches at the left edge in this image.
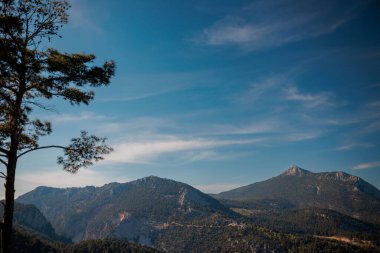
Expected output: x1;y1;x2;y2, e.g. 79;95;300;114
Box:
0;0;115;253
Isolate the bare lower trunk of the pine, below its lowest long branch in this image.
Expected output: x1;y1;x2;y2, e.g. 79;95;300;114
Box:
2;154;17;253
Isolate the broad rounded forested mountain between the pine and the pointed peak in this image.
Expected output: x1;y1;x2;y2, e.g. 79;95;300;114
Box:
17;176;235;245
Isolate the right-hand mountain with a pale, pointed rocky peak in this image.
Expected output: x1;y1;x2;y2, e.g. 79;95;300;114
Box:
214;166;380;224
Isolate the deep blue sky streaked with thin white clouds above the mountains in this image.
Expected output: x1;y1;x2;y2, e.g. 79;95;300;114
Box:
7;0;380;197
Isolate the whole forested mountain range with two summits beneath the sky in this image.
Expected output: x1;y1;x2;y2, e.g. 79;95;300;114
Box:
17;166;380;252
